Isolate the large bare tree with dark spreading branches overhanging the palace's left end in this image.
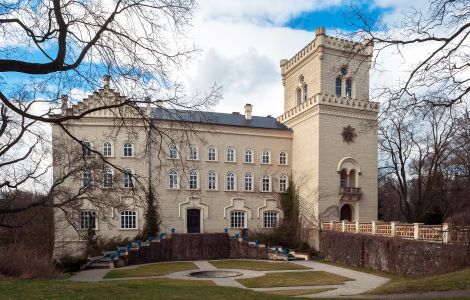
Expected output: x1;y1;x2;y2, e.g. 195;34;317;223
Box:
0;0;220;226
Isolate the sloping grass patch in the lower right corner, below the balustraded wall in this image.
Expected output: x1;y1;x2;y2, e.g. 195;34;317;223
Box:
368;269;470;294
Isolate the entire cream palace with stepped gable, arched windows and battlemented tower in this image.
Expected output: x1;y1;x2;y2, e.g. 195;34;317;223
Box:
53;28;378;253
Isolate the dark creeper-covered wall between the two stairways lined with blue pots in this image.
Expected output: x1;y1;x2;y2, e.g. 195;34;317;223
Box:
125;233;268;266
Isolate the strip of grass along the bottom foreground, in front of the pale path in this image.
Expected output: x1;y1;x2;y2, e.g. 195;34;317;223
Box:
0;278;302;300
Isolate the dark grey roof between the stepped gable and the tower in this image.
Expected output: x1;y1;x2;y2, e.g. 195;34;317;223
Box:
152;107;289;130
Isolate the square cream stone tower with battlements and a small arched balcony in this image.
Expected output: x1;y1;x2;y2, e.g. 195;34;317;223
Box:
278;28;378;245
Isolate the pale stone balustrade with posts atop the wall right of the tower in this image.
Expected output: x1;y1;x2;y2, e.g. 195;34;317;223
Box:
321;221;470;243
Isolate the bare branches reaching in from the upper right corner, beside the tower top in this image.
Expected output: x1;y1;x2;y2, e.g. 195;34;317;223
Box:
346;0;470;109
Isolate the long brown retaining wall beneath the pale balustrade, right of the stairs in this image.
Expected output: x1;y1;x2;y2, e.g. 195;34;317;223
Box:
320;231;470;276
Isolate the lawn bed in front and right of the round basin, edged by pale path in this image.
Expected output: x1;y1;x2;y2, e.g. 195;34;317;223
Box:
238;271;351;288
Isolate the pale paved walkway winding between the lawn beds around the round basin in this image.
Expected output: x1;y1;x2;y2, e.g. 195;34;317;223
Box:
70;261;389;298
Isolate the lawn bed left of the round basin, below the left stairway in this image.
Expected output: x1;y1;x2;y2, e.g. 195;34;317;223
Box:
104;262;198;278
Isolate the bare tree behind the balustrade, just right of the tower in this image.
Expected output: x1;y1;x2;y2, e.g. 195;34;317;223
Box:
379;105;457;222
